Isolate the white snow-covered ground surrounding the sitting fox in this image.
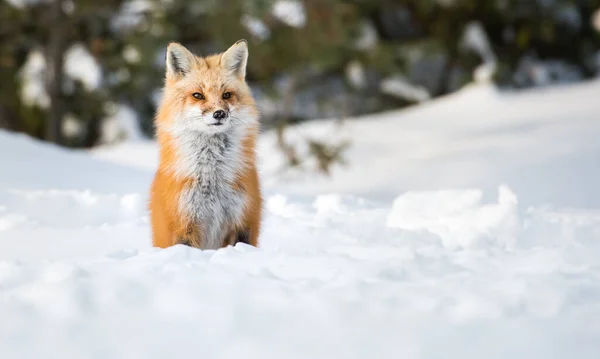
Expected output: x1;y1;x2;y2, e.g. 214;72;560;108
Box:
0;81;600;359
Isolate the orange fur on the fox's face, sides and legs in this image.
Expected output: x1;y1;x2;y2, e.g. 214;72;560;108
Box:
149;43;262;248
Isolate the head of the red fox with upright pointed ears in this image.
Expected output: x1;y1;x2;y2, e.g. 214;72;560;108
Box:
159;40;258;134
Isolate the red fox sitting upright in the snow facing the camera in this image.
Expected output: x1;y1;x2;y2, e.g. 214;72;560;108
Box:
149;40;262;249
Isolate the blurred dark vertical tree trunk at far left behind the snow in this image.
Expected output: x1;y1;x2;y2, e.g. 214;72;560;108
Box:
45;0;67;144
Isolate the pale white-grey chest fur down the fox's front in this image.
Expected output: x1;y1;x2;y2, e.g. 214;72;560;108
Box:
175;131;246;249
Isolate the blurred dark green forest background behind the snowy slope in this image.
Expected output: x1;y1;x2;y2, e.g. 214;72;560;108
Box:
0;0;600;154
